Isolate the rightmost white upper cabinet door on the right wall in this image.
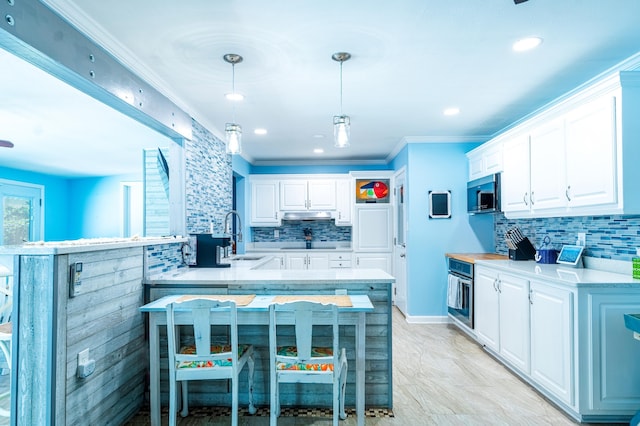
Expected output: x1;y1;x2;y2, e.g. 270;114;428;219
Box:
565;95;617;207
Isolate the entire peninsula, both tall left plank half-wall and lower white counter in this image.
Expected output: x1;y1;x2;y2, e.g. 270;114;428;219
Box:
0;237;394;424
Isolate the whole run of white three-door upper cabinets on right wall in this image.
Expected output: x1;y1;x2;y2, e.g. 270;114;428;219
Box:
498;75;640;218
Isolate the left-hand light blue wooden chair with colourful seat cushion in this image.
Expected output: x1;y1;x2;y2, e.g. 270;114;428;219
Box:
167;298;256;426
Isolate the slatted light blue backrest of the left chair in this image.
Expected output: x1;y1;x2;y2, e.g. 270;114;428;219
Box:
167;299;238;368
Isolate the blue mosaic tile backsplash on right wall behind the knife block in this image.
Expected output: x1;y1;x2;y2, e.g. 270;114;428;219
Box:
494;214;640;261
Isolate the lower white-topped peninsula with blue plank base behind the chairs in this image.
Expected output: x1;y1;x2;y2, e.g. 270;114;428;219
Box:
145;254;395;420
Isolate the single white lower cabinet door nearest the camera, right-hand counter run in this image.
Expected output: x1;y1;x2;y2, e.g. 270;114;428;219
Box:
529;281;574;405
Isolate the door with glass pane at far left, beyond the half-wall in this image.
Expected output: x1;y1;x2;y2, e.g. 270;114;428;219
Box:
0;179;44;245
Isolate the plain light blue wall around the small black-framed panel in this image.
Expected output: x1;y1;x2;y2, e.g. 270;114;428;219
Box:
404;143;494;317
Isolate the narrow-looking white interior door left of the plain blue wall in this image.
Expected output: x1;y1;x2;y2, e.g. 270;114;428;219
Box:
393;169;408;315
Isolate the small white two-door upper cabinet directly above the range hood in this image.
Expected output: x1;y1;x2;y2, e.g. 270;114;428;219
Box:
280;179;336;211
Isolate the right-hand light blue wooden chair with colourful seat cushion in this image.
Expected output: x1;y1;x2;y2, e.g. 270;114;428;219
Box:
269;301;347;426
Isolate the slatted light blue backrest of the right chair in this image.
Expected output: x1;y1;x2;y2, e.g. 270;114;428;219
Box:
269;301;340;365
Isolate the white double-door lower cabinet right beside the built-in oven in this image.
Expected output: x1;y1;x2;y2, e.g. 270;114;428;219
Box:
474;266;530;373
